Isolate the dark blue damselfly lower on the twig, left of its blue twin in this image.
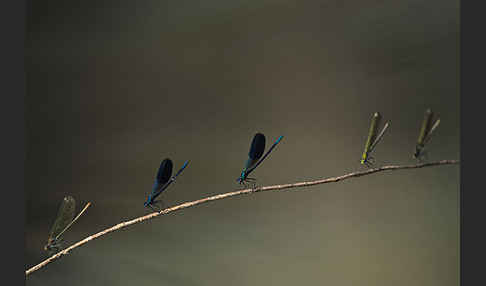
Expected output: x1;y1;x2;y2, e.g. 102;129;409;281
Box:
143;158;189;211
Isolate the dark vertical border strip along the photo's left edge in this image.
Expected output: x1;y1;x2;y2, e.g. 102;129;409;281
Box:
0;0;27;285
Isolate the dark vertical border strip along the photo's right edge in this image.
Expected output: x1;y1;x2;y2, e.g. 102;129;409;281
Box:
459;0;486;285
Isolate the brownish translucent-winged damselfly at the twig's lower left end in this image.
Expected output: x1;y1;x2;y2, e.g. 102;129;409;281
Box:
44;196;91;252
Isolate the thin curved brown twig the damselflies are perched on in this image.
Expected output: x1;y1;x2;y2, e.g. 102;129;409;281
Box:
25;160;459;276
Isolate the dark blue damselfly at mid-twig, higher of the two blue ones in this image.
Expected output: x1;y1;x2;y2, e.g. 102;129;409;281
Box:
236;133;283;185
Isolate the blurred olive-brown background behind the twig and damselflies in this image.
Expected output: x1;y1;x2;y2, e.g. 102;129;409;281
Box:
25;0;460;286
